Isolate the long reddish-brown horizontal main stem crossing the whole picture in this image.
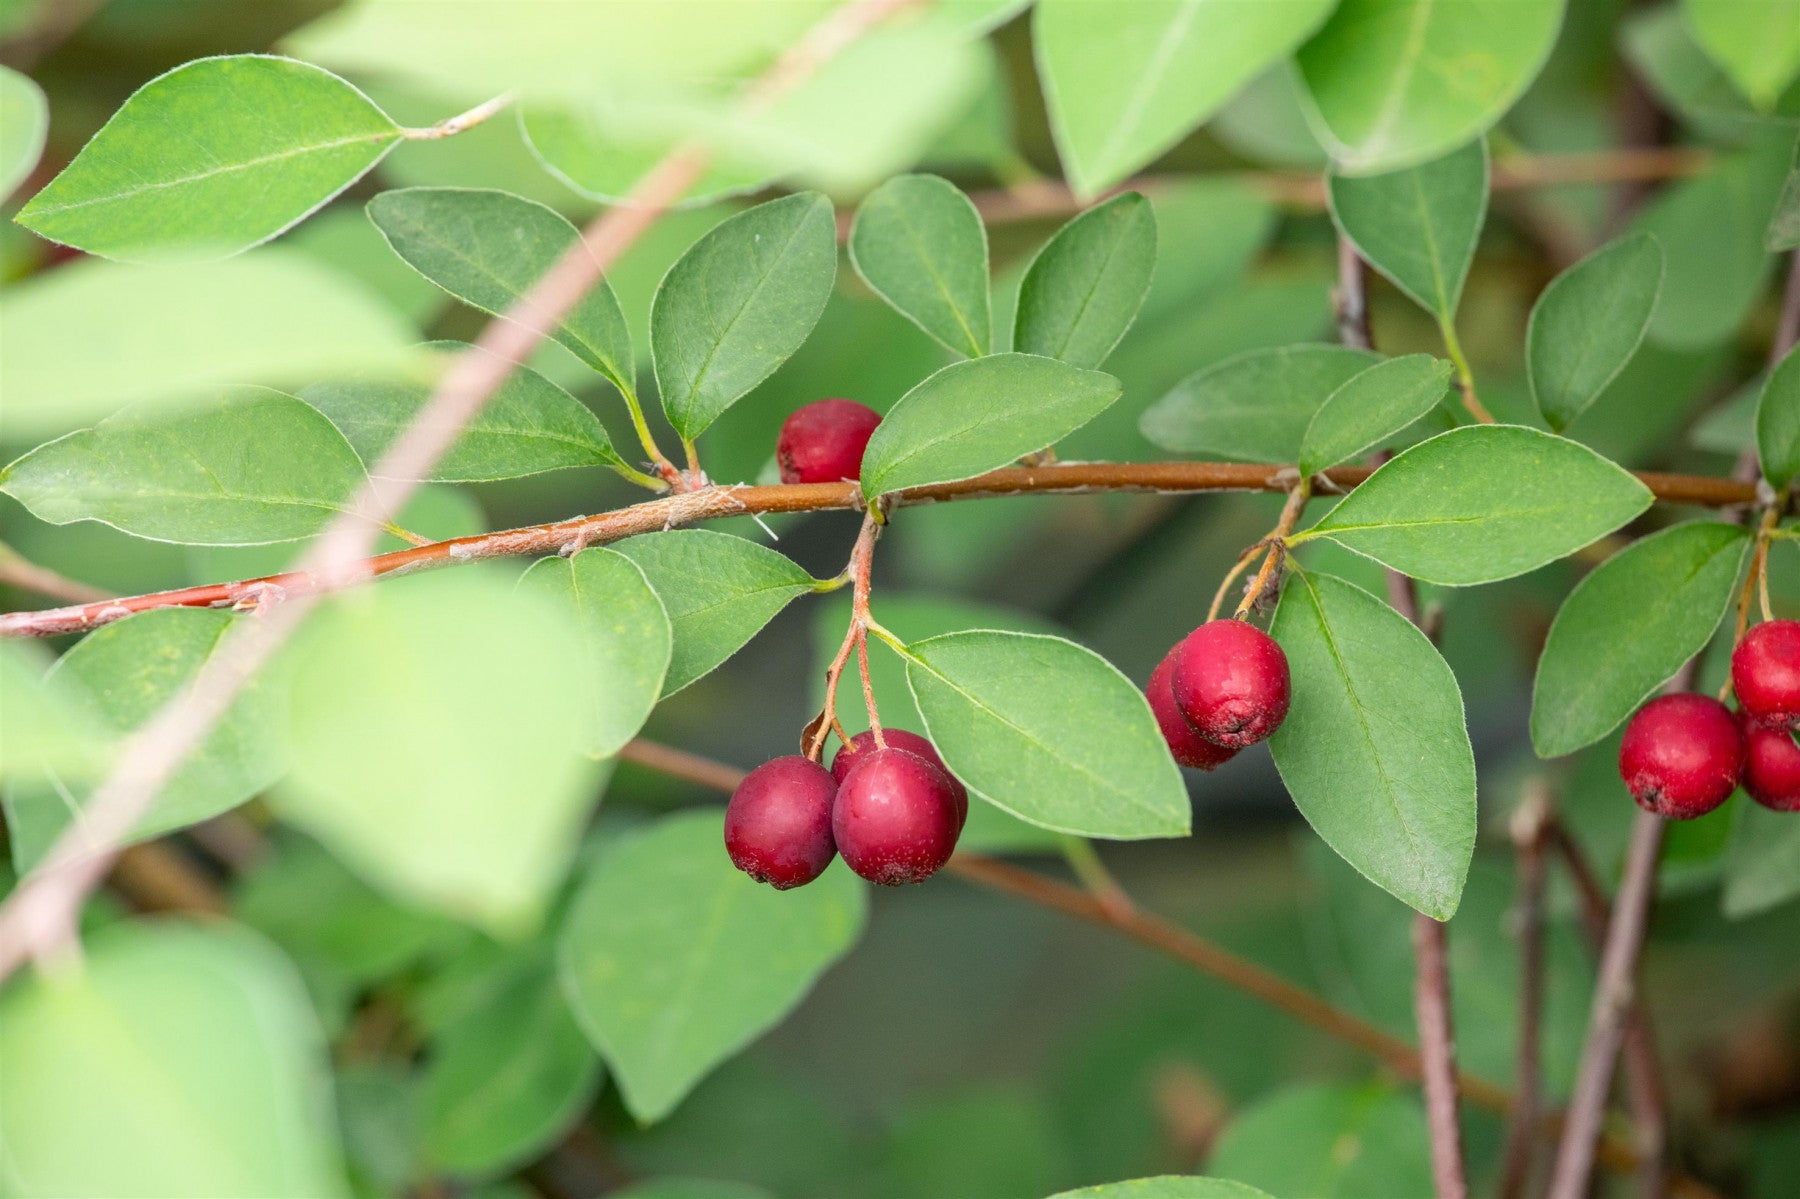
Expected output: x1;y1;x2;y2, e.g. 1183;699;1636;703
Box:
0;463;1757;637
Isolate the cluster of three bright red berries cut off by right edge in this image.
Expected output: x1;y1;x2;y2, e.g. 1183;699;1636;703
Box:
1618;621;1800;821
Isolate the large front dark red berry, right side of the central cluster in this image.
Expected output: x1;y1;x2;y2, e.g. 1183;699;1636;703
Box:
832;747;958;888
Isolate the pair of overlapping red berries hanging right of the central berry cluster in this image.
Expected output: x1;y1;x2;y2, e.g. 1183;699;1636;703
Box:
1145;619;1289;771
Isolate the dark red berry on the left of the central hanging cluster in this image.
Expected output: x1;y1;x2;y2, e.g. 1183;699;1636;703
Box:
725;754;837;891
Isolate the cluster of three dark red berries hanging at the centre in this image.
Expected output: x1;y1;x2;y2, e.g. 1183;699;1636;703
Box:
725;729;968;891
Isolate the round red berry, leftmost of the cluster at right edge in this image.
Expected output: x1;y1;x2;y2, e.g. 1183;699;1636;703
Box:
1618;691;1744;821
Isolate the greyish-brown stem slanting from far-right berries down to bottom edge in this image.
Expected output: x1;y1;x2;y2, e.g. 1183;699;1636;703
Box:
1550;812;1665;1199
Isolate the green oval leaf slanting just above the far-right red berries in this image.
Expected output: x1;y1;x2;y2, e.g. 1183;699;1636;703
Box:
1532;520;1750;758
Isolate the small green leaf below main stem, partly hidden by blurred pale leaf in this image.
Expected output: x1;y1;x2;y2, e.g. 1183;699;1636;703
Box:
518;545;675;758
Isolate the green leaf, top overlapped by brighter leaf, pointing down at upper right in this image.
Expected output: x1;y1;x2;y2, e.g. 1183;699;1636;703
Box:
1328;140;1490;324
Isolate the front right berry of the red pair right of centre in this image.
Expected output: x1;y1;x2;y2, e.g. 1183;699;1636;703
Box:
1168;621;1289;749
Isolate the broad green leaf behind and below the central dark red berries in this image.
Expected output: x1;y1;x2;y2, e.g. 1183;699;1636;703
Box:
558;808;868;1123
